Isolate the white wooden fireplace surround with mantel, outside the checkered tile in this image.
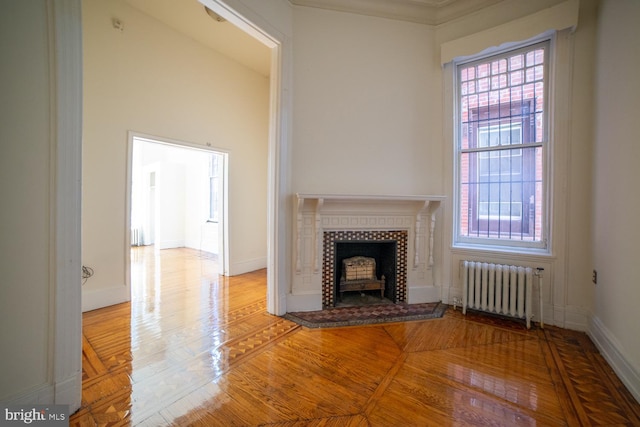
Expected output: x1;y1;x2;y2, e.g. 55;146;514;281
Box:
287;193;445;312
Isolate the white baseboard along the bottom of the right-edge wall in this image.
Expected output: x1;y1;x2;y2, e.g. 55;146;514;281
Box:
587;317;640;402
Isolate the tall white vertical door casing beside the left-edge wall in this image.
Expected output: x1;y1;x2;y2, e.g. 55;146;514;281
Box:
49;0;82;412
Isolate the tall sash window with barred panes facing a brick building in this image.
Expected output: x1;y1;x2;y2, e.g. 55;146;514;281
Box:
456;42;549;248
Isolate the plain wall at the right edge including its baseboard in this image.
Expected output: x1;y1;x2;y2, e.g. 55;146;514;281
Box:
591;0;640;400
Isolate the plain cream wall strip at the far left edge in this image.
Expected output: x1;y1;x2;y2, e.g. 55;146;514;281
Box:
0;1;54;401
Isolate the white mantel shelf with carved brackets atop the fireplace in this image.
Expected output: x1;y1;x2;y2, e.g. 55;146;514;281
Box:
296;193;445;273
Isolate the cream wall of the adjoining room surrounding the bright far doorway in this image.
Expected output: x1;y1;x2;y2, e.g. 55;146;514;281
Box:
82;0;269;310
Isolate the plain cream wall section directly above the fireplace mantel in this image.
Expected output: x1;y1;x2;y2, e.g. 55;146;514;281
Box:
292;7;443;194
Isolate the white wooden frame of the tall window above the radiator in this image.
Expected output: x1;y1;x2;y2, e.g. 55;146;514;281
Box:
452;35;554;253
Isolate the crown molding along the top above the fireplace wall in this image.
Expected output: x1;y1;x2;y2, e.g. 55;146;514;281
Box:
290;0;502;25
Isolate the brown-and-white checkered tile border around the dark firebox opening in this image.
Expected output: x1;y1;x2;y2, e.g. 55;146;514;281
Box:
322;230;408;308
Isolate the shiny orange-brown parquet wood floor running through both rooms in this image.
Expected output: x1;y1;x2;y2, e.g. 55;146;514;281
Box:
70;248;640;427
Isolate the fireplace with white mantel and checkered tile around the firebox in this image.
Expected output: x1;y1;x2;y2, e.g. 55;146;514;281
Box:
287;194;444;312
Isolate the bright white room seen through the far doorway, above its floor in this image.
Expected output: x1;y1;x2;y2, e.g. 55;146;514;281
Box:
129;134;228;285
